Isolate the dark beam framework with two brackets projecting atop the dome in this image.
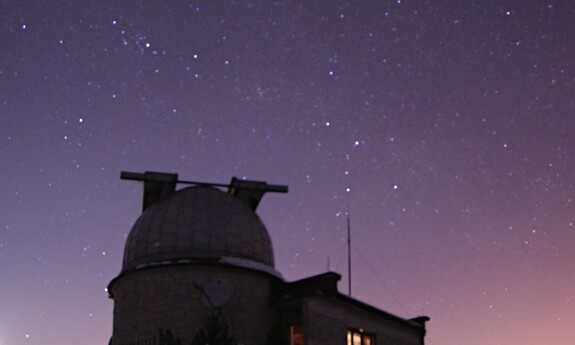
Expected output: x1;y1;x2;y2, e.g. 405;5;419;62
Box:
120;171;288;211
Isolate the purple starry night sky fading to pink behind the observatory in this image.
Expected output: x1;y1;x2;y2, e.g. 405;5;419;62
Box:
0;0;575;345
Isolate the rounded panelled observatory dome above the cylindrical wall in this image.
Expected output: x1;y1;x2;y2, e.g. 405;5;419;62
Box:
122;186;274;271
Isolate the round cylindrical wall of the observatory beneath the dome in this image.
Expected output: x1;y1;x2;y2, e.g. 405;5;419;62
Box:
110;265;271;345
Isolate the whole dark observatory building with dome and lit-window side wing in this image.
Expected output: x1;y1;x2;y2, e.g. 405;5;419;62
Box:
108;172;429;345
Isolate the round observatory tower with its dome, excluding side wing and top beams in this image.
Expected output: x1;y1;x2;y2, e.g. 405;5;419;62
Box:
108;180;281;345
